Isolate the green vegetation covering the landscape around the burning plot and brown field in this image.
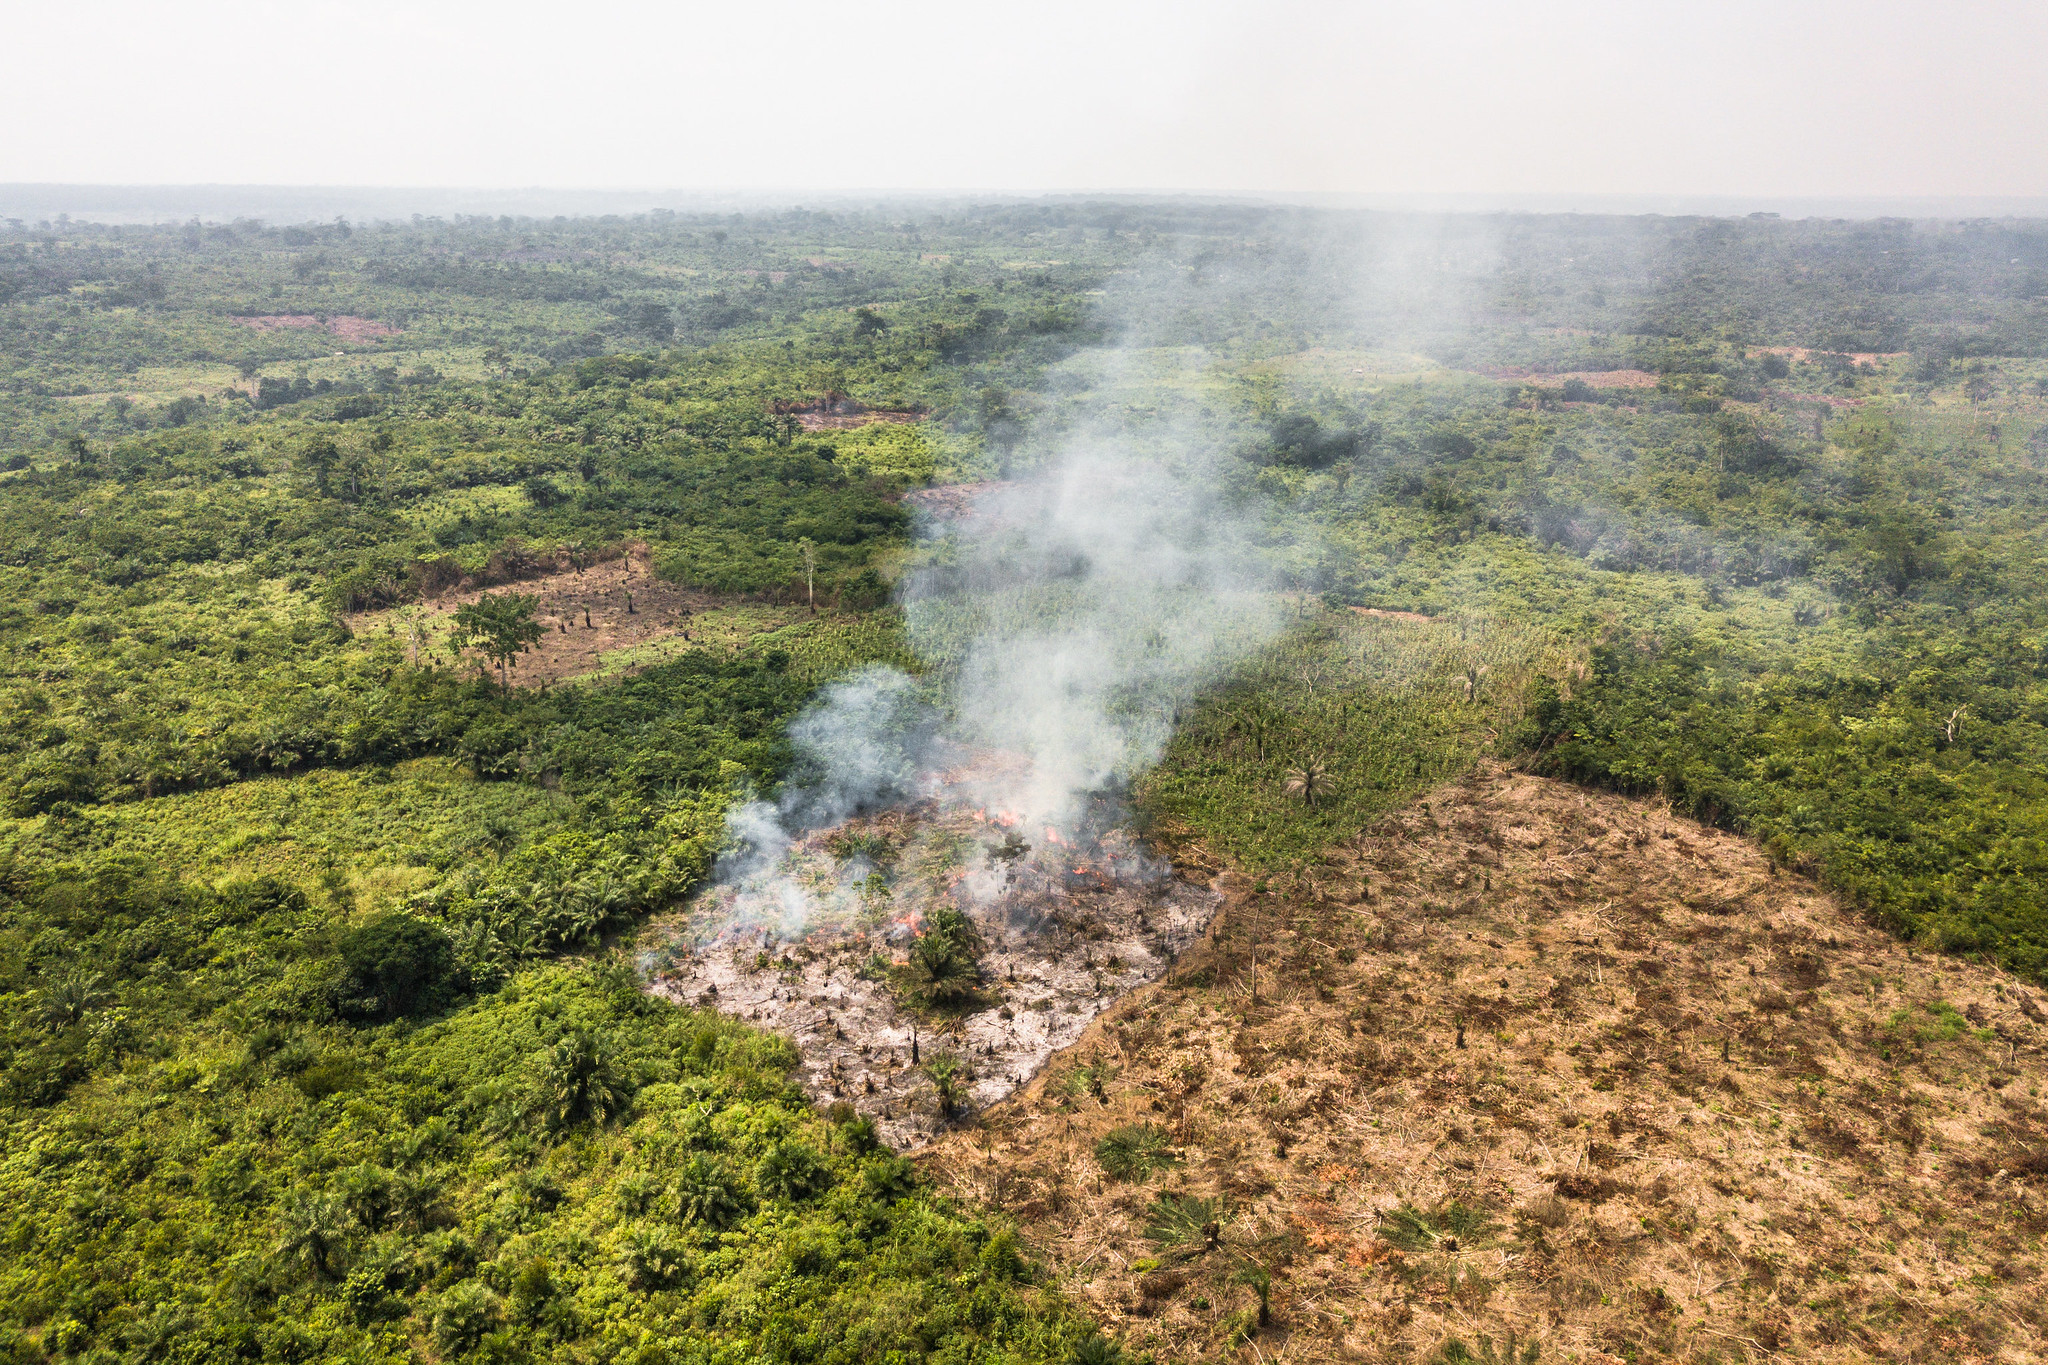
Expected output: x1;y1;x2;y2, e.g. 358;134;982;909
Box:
12;203;2048;1361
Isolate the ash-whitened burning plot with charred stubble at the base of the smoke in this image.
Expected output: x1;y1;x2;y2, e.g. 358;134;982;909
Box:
645;800;1219;1148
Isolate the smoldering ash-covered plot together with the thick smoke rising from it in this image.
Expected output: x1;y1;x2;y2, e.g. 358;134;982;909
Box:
651;317;1282;1144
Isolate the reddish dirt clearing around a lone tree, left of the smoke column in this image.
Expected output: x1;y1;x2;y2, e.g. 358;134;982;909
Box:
350;546;770;688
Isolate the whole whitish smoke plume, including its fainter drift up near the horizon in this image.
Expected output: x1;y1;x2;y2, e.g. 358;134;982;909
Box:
696;215;1531;937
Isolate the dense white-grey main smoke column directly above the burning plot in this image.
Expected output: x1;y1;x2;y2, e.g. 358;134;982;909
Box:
719;354;1280;937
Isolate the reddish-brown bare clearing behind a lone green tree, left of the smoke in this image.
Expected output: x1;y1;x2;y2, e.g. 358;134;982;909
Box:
348;544;790;688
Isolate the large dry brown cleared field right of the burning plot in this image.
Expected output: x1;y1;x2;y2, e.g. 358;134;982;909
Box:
920;767;2048;1363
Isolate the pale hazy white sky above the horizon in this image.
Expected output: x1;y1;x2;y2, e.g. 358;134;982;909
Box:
16;0;2048;194
